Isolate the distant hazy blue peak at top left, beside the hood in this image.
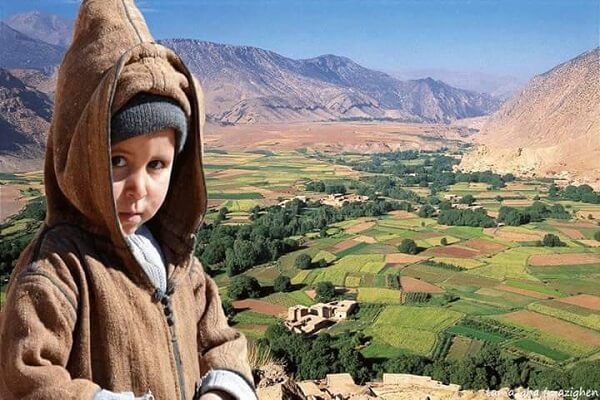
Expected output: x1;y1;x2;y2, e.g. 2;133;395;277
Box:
4;11;73;47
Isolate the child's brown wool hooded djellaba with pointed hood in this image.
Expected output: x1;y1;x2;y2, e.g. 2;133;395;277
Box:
0;0;251;400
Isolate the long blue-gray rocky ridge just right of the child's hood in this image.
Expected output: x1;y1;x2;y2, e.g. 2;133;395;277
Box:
161;39;499;123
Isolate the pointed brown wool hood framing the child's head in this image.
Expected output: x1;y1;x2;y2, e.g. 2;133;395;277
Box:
45;0;207;272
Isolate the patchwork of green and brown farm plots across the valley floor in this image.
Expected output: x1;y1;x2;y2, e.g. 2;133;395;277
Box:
0;145;600;376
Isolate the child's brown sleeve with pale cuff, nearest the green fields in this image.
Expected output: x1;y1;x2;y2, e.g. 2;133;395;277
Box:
192;259;256;399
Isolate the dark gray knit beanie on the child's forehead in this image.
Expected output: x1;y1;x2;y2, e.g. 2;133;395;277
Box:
110;93;187;155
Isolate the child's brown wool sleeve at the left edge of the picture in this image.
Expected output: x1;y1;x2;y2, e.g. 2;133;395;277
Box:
0;256;100;400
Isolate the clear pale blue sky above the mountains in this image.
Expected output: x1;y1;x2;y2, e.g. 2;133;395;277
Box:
0;0;600;78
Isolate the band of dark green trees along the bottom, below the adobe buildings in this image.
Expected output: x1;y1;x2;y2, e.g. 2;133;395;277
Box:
259;325;600;390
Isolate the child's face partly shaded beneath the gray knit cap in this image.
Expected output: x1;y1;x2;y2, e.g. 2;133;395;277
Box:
111;129;175;235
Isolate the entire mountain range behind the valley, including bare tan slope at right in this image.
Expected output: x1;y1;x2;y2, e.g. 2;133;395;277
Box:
0;12;600;185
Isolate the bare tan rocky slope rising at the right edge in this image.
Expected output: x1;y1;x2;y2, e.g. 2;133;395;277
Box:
460;48;600;187
